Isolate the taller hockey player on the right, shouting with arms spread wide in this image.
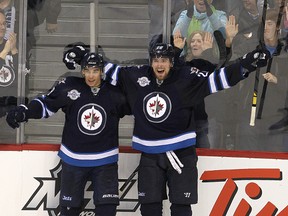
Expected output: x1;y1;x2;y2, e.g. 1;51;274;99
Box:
62;44;269;216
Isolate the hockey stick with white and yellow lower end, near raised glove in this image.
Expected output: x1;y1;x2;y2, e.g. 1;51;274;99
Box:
250;0;267;126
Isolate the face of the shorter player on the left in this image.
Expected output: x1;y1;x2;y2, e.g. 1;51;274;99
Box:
82;67;102;87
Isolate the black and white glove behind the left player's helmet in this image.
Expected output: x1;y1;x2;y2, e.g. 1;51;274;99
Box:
63;42;88;70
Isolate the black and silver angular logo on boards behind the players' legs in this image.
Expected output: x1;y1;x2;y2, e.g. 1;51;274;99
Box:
22;163;140;216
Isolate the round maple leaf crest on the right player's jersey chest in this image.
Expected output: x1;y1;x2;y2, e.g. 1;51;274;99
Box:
143;92;172;123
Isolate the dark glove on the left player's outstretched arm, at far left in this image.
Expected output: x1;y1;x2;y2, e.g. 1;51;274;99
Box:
6;104;28;129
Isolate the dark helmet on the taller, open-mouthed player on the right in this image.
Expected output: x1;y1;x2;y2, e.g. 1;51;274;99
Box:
149;43;175;61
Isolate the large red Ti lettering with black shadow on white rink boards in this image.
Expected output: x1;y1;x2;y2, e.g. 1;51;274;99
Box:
200;169;288;216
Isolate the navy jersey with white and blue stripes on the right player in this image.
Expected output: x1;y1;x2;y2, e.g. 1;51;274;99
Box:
105;63;249;154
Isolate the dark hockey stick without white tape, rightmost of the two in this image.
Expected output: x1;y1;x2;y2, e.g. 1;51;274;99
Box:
257;0;285;119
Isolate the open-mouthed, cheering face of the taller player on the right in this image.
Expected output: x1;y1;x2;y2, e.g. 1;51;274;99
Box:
151;57;172;80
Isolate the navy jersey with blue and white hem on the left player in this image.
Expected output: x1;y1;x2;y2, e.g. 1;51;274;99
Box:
28;77;129;167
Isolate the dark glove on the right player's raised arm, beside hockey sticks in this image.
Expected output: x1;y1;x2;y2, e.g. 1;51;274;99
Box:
240;49;271;72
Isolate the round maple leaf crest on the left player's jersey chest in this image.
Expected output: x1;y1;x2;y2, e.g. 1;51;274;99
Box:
77;104;107;135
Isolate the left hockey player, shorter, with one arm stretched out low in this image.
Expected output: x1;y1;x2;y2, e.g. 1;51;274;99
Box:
7;51;130;216
